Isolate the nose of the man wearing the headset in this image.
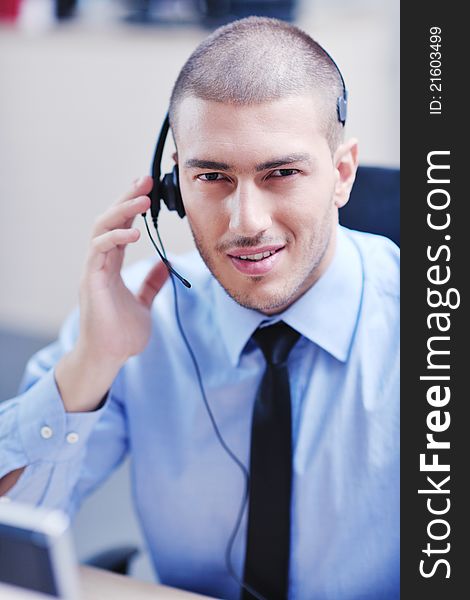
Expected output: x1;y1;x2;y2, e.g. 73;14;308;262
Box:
229;184;272;237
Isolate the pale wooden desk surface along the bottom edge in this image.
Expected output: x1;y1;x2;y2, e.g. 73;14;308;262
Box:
0;566;217;600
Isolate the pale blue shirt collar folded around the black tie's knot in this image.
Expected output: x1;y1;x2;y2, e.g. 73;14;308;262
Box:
214;227;364;366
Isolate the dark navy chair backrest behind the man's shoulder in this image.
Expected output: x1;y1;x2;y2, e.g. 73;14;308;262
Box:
339;167;400;246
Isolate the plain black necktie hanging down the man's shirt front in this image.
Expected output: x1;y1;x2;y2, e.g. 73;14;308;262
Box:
242;322;299;600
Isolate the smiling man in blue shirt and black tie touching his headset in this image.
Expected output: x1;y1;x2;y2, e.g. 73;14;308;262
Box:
0;18;399;600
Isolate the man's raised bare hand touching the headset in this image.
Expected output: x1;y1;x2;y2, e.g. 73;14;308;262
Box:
55;177;168;412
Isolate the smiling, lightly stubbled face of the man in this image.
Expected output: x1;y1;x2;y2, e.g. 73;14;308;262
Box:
177;96;356;314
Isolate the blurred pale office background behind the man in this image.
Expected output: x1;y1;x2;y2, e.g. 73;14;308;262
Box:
0;0;399;579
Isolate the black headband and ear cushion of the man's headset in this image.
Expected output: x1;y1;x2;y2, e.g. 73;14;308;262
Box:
149;46;348;231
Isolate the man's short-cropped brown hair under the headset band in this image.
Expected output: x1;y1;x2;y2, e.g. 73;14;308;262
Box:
169;17;343;153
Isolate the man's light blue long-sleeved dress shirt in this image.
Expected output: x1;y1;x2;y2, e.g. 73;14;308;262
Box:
0;227;399;600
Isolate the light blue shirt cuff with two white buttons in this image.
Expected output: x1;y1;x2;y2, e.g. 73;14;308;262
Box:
18;369;105;464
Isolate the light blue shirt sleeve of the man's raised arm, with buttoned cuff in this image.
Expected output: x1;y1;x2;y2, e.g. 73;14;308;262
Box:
0;313;128;514
